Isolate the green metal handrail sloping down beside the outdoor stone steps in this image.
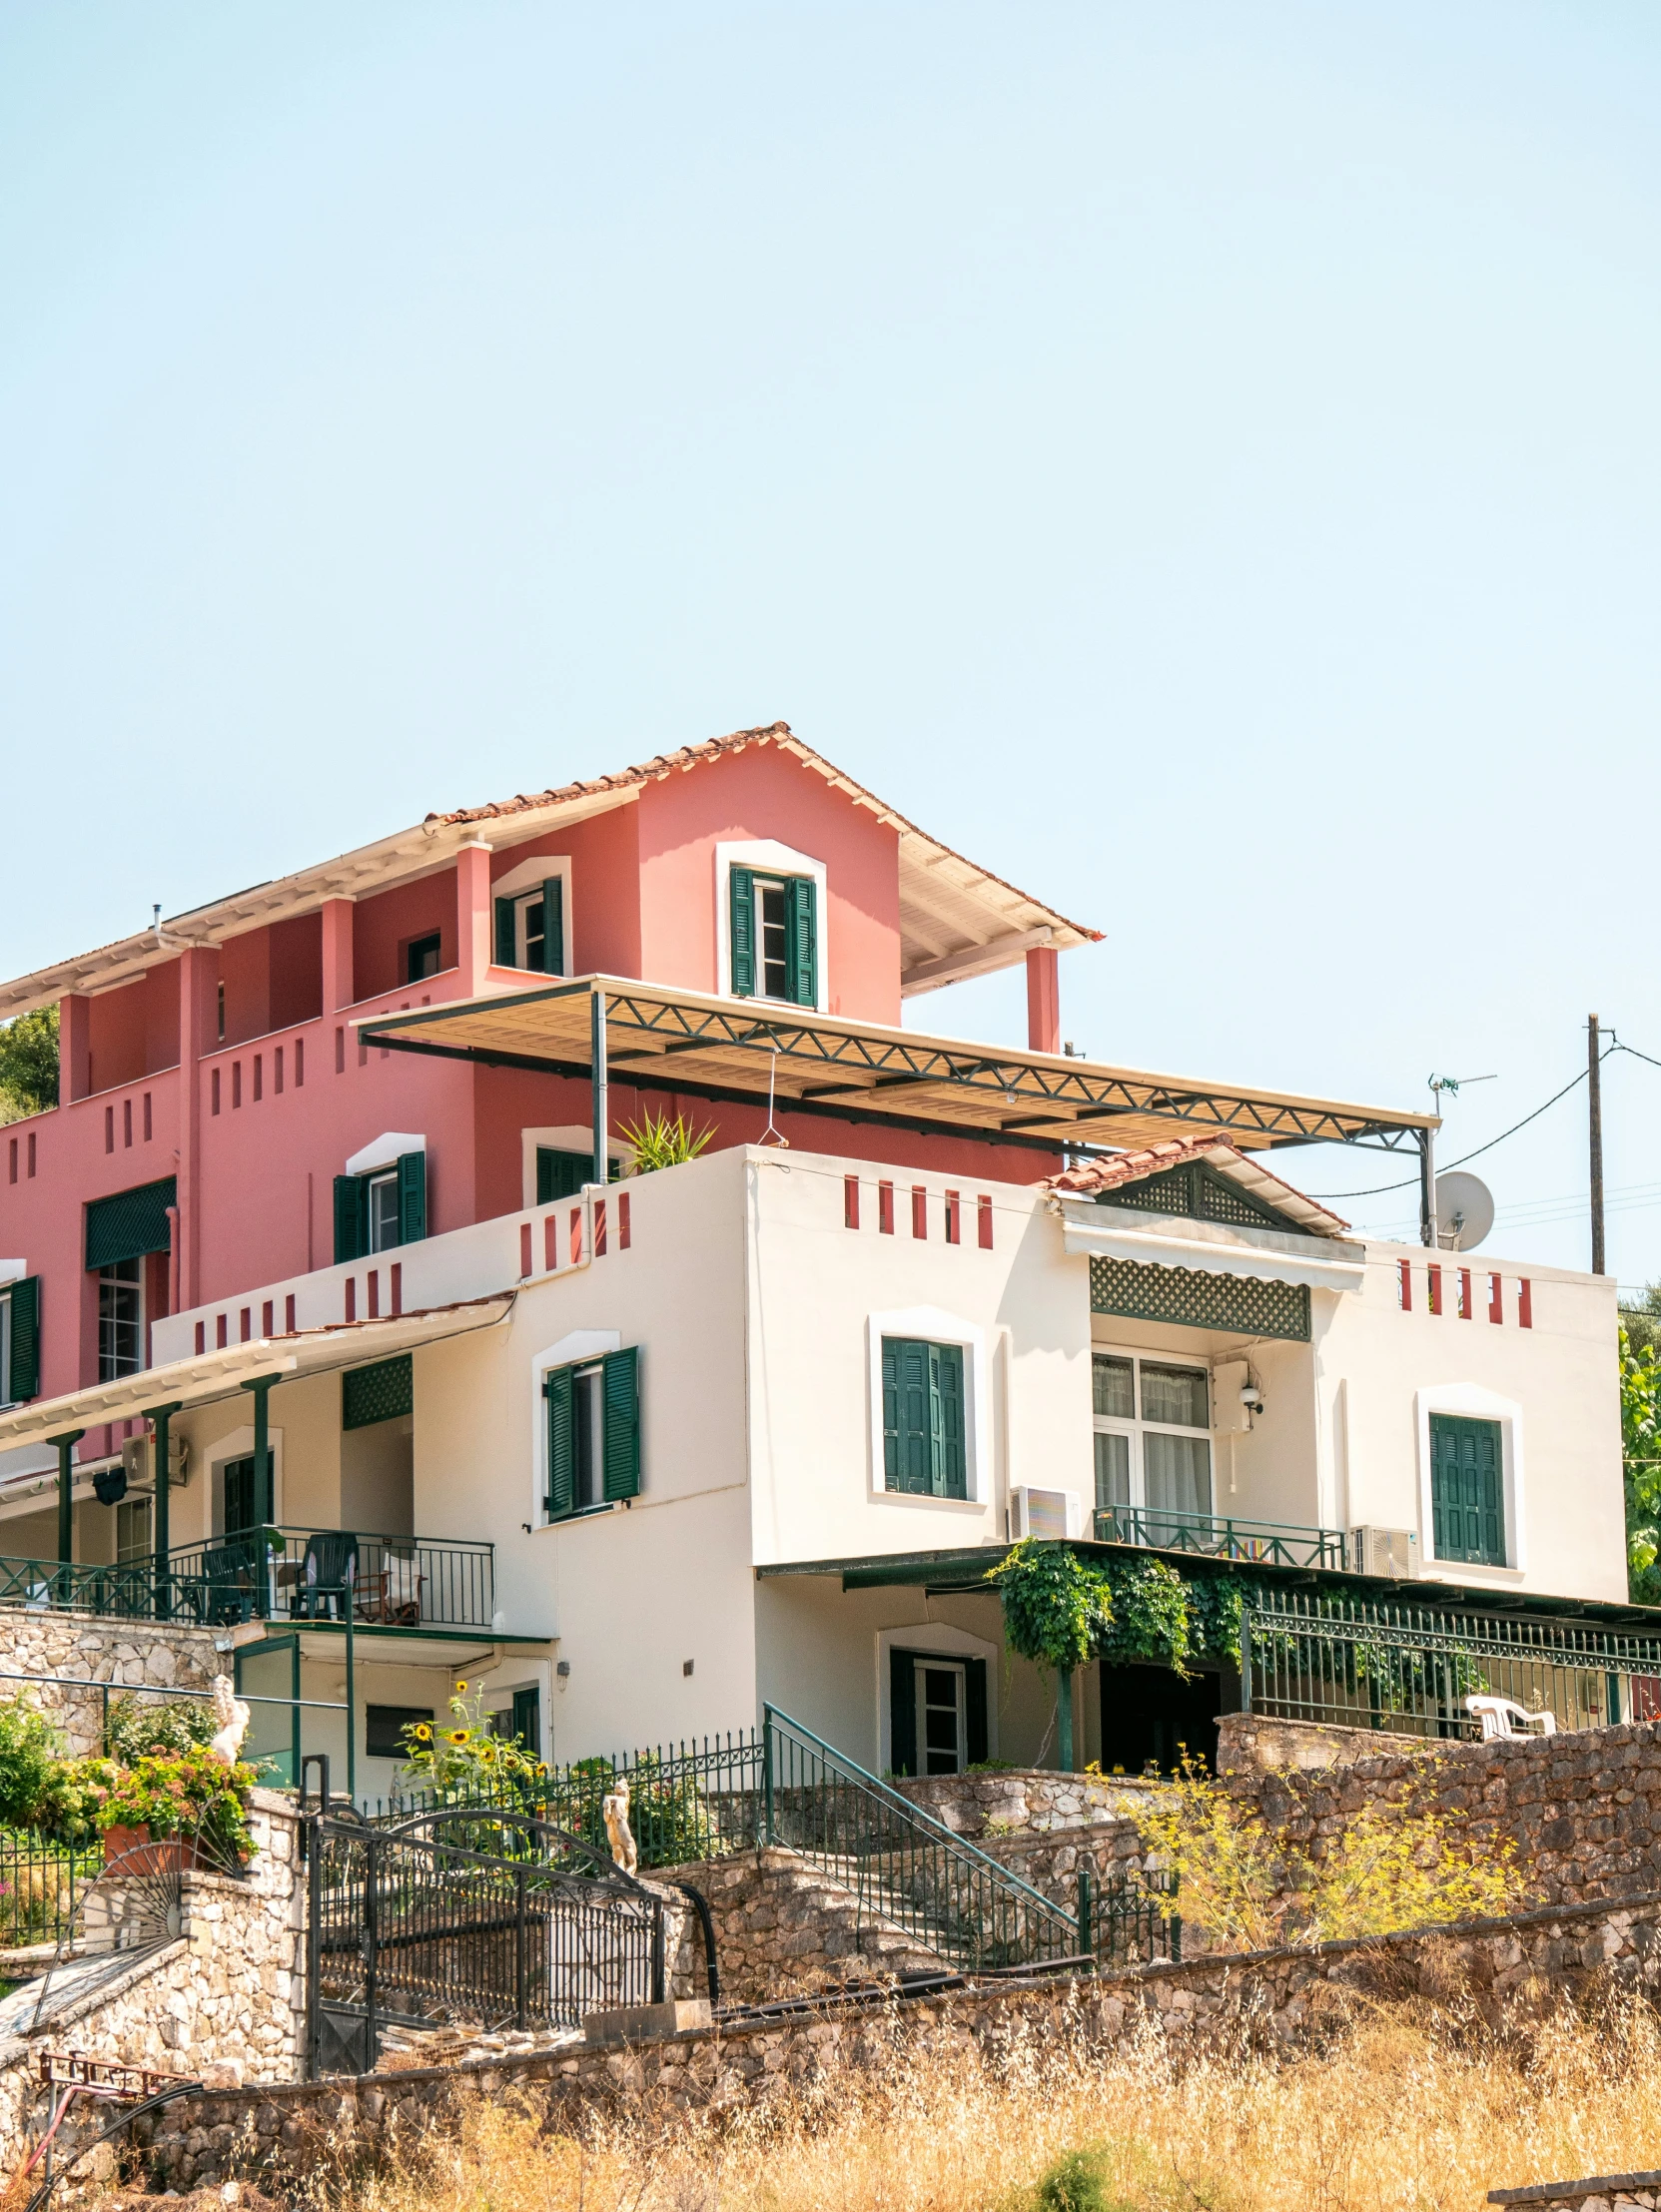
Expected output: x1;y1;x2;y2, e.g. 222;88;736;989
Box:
761;1706;1080;1966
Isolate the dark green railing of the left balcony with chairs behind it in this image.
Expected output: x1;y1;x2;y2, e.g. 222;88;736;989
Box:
0;1529;495;1628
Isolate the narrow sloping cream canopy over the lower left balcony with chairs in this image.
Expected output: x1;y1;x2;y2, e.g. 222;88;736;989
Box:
0;1292;513;1451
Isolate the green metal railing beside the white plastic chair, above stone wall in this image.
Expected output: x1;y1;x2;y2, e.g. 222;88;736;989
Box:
1241;1591;1661;1737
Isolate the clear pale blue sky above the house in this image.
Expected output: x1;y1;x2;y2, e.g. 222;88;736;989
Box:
0;0;1661;1283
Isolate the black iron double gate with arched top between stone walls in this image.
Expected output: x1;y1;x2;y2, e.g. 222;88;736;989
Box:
306;1805;666;2079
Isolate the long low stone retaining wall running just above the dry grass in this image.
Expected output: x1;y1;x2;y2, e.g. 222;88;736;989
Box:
110;1891;1661;2190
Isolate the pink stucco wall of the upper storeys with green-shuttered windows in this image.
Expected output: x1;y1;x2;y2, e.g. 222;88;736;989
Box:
0;748;1060;1449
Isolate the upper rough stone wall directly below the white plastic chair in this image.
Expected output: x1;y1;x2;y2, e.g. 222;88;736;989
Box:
1219;1715;1661;1904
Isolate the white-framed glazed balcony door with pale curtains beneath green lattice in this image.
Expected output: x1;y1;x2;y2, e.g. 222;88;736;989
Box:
1091;1349;1212;1544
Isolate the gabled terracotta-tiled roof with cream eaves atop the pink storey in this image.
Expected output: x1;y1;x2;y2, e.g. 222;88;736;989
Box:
0;721;1102;1020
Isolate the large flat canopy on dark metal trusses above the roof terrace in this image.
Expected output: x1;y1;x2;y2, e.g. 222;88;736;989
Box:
354;976;1437;1152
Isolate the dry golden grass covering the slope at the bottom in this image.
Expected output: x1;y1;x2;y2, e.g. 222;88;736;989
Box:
338;2004;1661;2212
